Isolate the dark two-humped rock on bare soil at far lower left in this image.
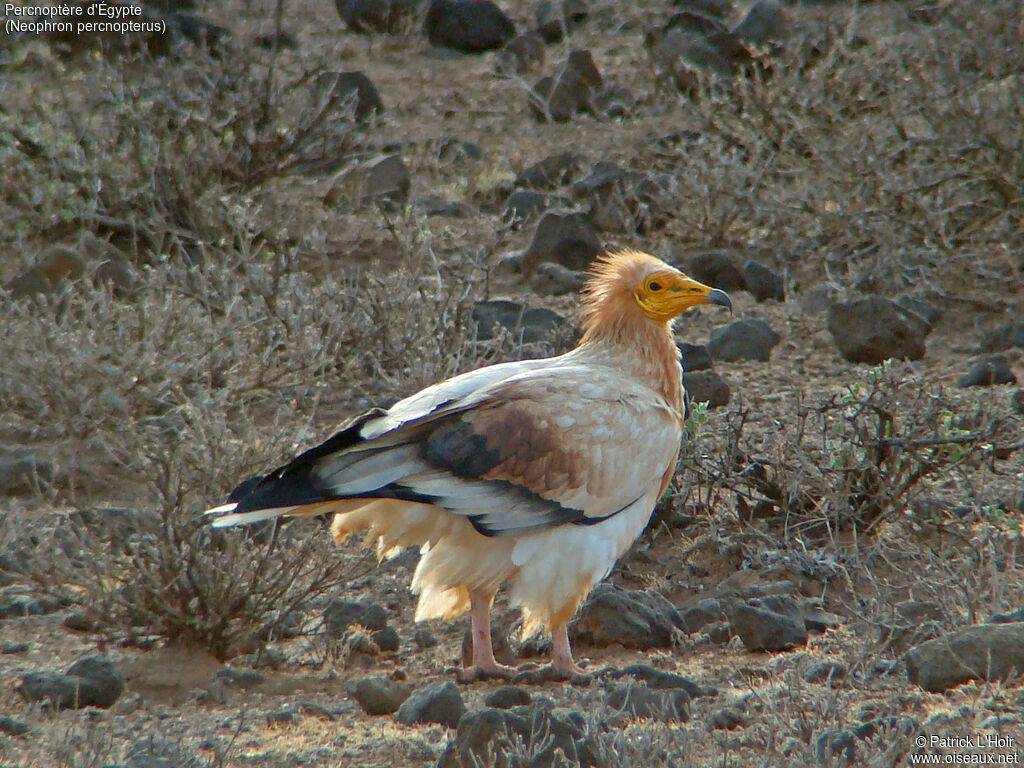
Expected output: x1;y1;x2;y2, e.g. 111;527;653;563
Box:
14;656;125;710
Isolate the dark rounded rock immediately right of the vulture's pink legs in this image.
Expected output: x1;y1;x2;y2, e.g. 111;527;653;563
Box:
569;584;683;650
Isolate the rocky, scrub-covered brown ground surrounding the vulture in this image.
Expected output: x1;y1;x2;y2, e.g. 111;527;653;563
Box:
0;0;1024;768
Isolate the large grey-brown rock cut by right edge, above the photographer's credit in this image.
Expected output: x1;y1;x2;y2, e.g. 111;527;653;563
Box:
903;622;1024;692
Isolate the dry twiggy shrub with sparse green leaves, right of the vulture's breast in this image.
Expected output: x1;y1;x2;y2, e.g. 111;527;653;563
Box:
690;362;1024;538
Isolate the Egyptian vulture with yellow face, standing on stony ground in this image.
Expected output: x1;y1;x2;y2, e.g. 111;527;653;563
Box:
208;251;731;681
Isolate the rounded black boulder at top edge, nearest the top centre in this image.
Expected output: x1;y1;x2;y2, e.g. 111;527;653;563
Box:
424;0;515;53
